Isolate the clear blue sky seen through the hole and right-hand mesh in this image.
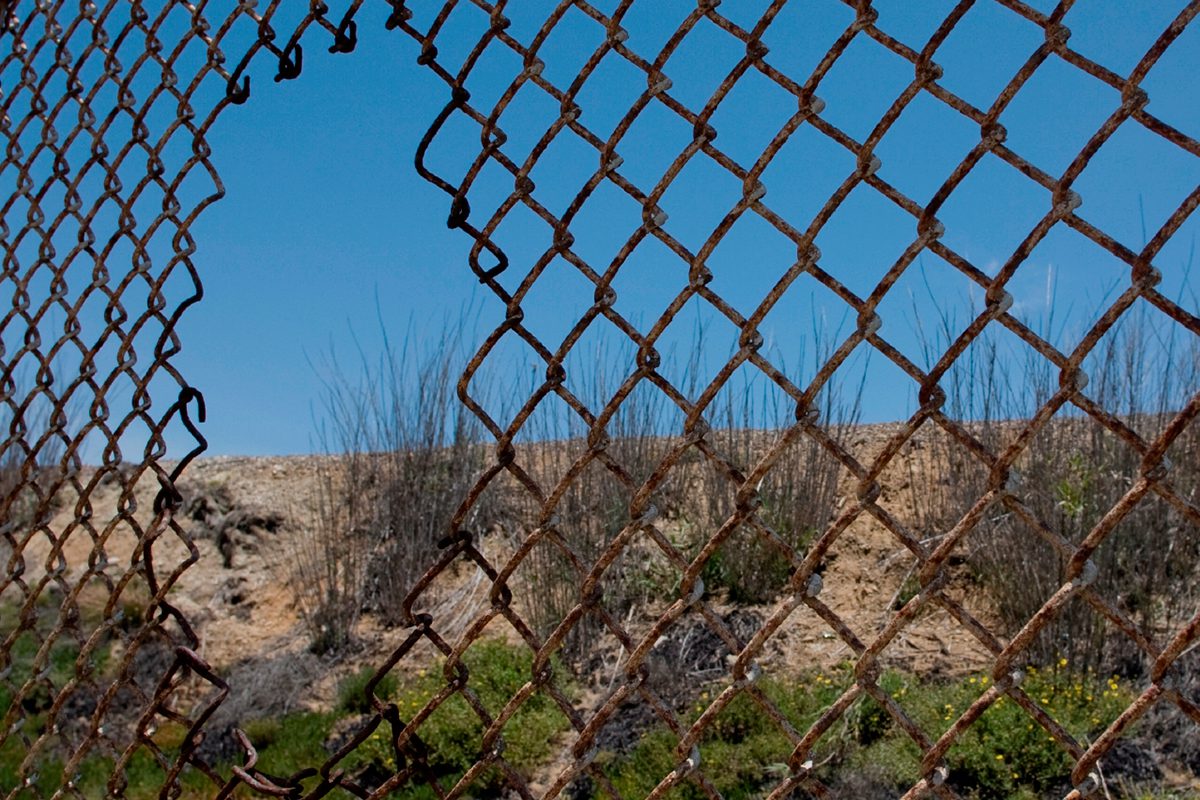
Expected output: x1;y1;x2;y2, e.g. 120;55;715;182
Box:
162;0;1200;455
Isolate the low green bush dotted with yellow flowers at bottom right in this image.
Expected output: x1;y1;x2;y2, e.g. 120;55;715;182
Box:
596;663;1133;800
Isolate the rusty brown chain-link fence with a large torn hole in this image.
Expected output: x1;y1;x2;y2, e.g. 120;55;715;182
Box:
0;0;1200;798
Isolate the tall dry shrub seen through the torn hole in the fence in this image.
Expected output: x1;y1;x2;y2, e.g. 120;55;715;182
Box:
293;320;484;651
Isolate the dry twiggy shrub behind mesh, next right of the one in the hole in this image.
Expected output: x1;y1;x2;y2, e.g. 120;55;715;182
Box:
497;350;683;663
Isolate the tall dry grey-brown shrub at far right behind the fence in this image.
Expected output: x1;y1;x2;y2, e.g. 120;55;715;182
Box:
914;299;1200;675
